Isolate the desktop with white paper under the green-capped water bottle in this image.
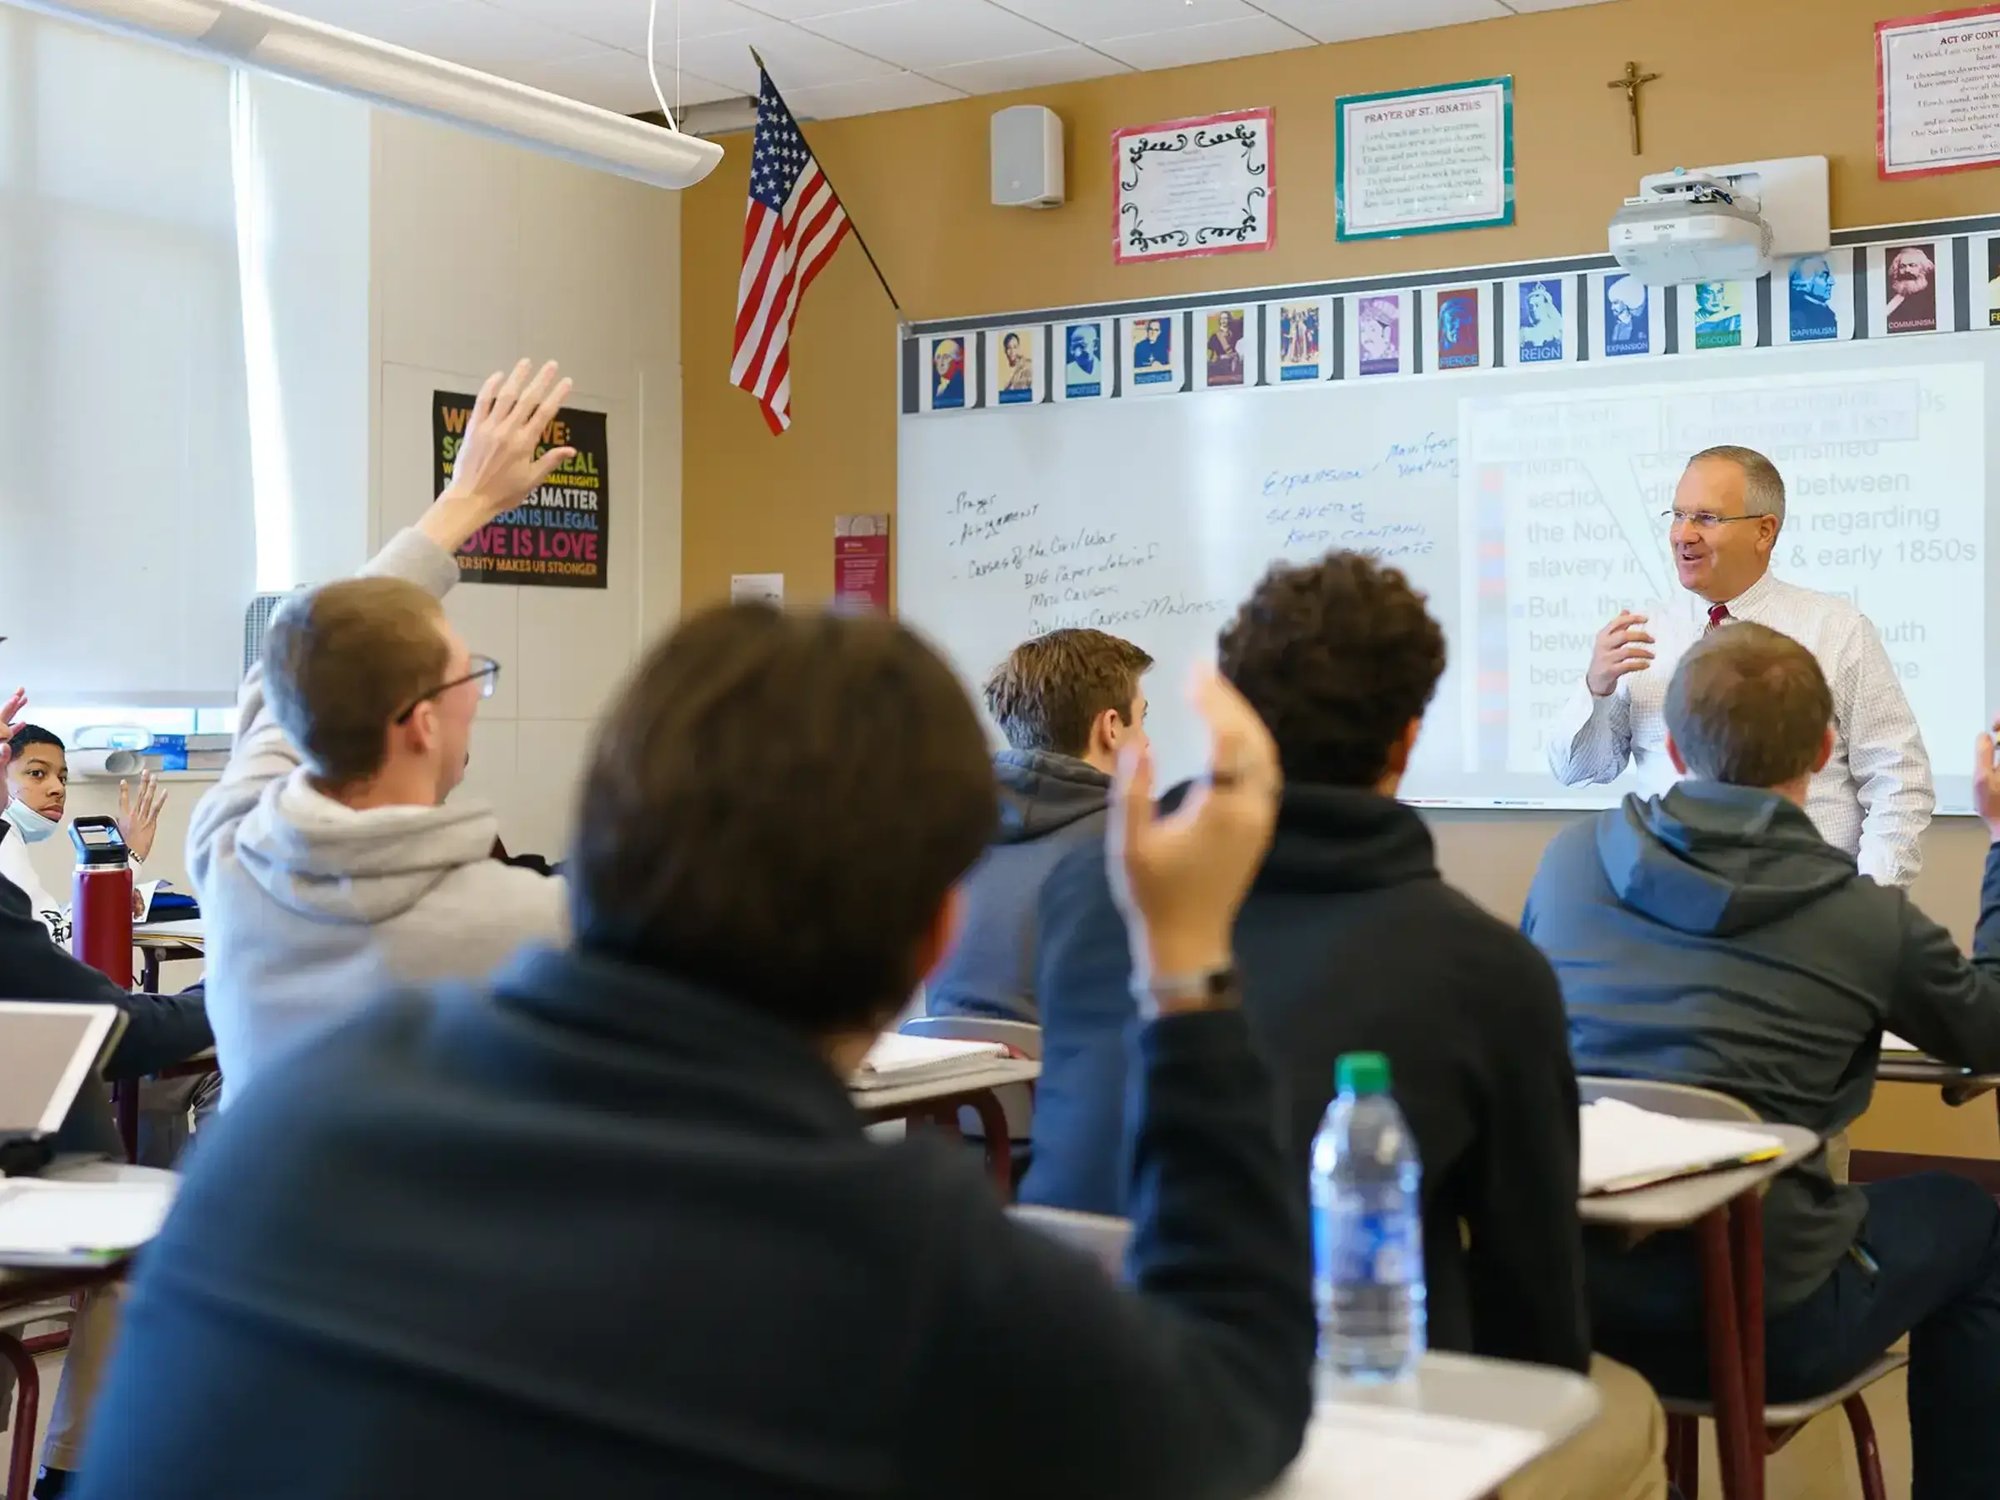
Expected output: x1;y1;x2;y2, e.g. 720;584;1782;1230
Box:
1266;1354;1600;1500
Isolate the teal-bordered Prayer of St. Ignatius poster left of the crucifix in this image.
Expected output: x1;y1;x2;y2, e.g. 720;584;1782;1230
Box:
1334;78;1514;240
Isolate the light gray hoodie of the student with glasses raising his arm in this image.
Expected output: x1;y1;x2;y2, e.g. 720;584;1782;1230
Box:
188;530;568;1106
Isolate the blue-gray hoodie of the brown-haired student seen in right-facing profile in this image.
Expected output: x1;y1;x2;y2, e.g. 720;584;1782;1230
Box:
926;750;1112;1024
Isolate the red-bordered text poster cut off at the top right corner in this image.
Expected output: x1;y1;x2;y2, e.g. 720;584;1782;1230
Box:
1876;6;2000;178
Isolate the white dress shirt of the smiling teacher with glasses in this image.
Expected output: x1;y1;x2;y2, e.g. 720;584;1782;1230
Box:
1548;572;1936;886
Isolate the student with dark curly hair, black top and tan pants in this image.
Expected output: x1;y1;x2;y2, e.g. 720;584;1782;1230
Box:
1022;552;1666;1500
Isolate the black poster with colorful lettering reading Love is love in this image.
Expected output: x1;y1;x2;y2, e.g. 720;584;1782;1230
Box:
430;390;612;588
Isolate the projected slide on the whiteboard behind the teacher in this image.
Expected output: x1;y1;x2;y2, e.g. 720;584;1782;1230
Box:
1458;360;1992;806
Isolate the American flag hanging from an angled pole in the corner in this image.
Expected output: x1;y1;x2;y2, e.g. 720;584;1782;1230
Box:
730;72;848;432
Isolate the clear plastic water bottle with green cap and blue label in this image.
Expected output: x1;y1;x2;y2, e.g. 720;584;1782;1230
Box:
1312;1052;1424;1384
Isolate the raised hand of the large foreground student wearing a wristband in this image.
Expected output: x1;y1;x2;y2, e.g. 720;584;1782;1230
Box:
1106;670;1282;992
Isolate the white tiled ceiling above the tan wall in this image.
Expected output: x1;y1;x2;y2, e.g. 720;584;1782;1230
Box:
272;0;1624;118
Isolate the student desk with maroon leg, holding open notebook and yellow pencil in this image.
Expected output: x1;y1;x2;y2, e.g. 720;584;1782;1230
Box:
1576;1124;1820;1500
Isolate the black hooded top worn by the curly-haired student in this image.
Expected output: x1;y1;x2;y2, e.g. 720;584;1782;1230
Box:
1022;784;1590;1370
